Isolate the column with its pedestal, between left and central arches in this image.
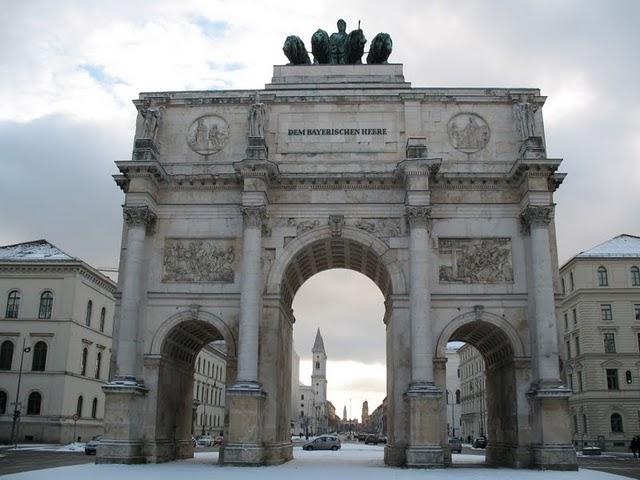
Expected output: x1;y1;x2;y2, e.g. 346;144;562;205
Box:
224;205;266;465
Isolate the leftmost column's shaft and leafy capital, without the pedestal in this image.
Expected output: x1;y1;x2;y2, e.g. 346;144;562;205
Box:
115;206;156;384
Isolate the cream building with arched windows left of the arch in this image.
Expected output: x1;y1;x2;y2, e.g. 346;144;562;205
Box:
0;240;116;443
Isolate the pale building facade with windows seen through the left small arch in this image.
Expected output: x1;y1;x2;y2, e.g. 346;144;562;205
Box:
193;340;227;436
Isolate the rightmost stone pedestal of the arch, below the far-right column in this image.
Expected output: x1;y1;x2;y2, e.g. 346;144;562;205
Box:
529;386;578;470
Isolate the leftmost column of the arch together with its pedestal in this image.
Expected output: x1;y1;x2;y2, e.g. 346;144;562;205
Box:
96;206;156;463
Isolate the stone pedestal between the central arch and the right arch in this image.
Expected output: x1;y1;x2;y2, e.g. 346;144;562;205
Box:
405;385;444;468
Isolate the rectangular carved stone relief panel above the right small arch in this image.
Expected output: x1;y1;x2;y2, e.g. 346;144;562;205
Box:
438;238;513;283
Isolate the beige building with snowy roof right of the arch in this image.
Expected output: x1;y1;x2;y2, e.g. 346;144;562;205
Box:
558;235;640;450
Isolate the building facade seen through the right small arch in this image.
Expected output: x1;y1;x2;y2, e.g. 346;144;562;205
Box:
458;344;488;442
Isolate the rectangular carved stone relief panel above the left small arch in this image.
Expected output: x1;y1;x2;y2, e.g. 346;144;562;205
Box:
162;238;236;283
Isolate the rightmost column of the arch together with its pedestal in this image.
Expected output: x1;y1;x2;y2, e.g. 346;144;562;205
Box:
520;205;578;470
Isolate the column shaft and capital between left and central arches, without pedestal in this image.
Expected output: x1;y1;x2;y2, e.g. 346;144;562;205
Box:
236;205;266;388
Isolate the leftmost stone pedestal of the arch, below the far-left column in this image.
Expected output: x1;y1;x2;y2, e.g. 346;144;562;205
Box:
96;383;147;464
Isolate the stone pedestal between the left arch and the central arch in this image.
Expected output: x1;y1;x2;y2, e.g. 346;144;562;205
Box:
219;387;266;465
